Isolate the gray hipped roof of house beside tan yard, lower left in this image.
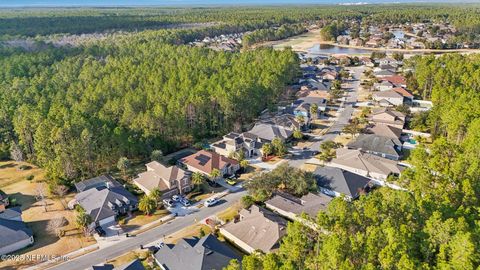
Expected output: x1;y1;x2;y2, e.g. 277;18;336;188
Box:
75;186;138;222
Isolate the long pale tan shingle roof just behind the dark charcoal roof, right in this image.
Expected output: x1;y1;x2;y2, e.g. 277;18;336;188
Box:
331;148;401;175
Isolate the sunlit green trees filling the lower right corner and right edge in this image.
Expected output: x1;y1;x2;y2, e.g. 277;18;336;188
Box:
227;54;480;270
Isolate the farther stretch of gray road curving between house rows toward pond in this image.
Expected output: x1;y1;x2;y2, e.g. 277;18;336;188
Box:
288;66;365;168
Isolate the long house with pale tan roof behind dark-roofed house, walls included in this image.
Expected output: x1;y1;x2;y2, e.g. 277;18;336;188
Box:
328;148;402;180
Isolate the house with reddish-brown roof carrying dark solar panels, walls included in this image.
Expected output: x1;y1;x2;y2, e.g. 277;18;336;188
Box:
180;150;240;177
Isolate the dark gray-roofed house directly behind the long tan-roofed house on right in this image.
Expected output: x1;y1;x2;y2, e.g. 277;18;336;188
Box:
347;134;402;160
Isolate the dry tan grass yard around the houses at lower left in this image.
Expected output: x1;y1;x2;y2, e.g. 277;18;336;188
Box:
0;161;95;269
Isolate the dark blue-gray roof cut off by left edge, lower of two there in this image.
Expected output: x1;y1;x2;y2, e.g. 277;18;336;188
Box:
0;218;33;248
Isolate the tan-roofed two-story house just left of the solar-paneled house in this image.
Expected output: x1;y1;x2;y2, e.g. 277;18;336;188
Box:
133;161;192;198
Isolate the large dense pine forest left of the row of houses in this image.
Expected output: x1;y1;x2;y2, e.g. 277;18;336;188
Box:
0;38;299;188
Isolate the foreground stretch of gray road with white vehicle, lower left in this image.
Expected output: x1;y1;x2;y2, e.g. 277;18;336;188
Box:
49;189;246;270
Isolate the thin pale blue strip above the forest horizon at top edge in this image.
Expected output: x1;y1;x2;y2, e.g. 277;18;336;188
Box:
0;0;464;7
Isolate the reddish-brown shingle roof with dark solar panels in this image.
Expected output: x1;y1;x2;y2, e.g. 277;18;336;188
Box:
180;150;238;174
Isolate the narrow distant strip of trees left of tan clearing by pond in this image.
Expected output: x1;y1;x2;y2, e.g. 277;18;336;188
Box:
242;24;307;47
